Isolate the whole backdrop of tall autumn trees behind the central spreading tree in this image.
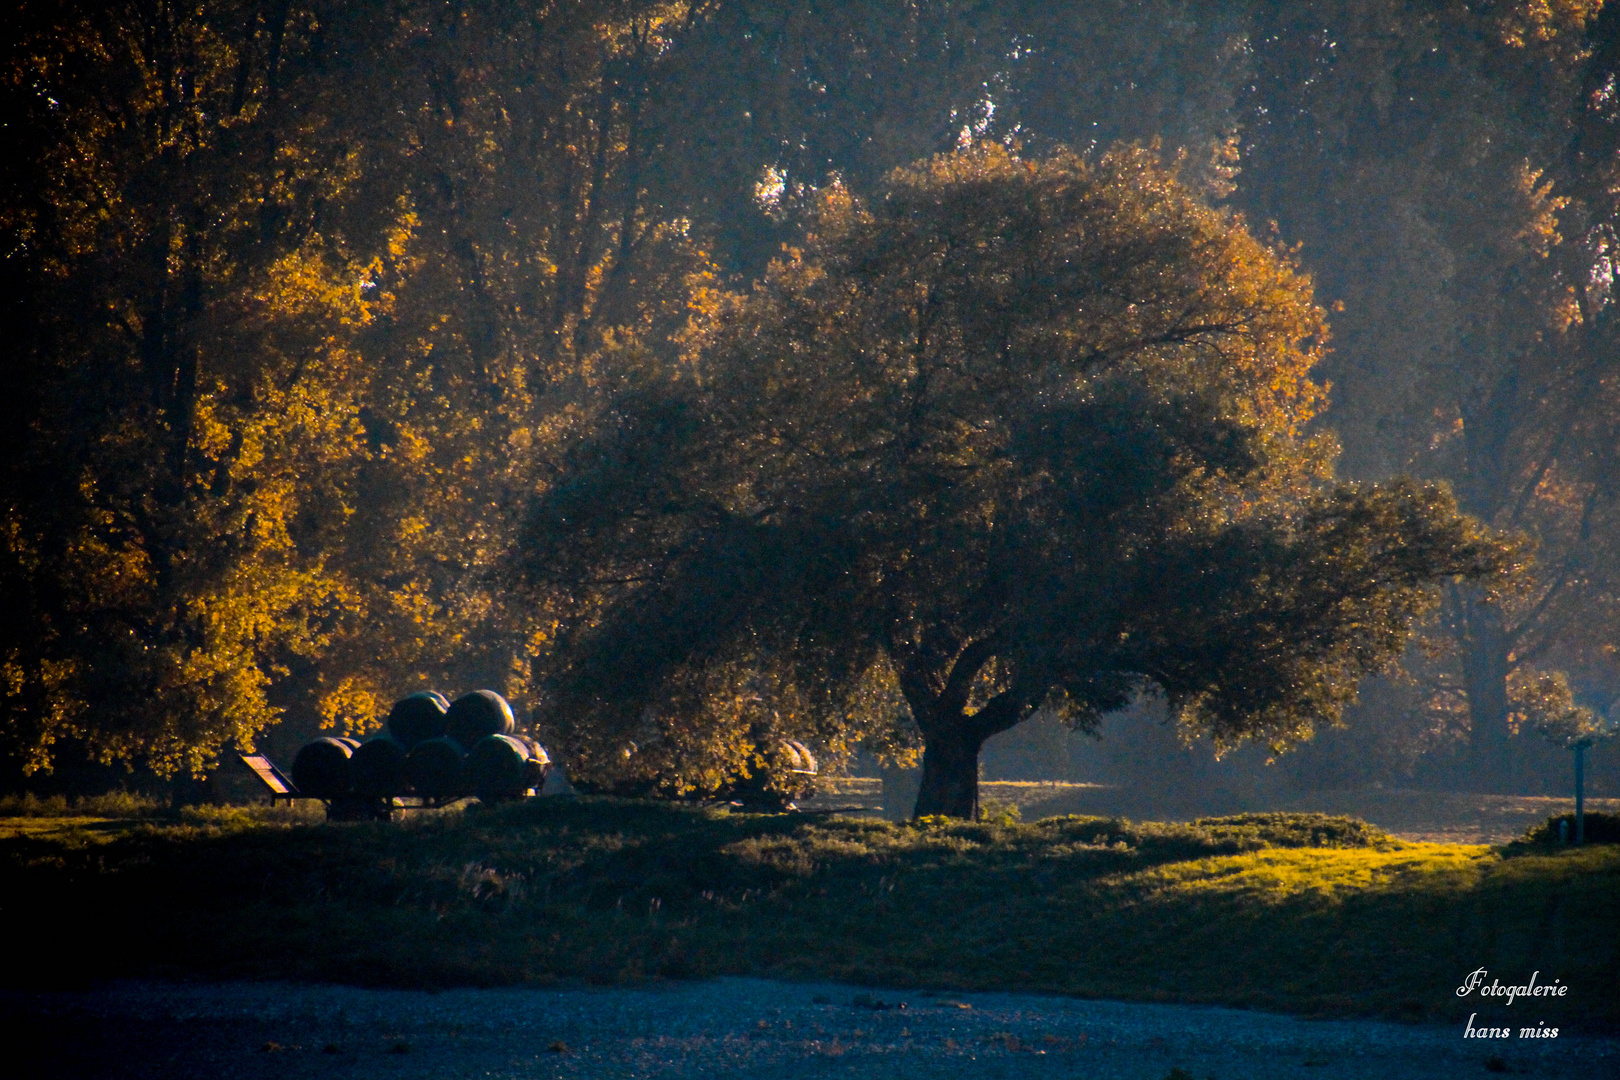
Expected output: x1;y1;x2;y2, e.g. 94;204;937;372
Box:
0;0;1620;784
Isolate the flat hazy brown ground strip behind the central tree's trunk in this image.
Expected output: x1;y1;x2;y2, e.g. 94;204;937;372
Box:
800;779;1620;844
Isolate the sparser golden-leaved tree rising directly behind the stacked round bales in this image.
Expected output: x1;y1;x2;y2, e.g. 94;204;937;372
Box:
294;0;732;727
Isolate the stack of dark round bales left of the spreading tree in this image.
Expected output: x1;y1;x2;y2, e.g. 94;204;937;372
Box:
293;690;551;801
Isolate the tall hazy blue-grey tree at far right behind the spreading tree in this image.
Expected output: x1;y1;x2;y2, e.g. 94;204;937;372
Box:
1236;0;1620;785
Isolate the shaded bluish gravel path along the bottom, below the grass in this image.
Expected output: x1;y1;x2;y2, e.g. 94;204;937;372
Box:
0;978;1620;1080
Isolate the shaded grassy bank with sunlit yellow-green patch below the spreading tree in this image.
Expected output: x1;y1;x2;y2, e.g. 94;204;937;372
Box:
0;798;1620;1028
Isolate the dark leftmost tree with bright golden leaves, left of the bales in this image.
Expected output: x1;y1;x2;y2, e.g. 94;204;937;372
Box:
0;3;400;772
